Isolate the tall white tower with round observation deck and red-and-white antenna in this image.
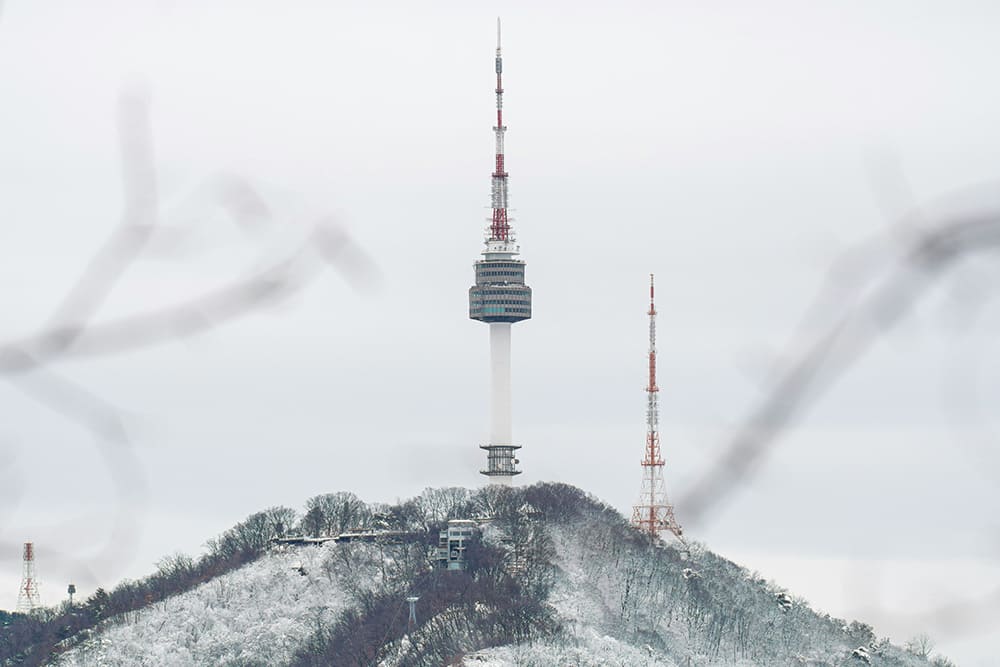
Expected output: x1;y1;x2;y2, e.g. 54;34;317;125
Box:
469;18;531;485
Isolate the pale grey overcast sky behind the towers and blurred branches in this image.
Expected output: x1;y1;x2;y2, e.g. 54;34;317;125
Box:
0;0;1000;665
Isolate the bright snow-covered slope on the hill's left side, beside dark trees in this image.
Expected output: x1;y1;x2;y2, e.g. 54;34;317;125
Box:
55;544;348;667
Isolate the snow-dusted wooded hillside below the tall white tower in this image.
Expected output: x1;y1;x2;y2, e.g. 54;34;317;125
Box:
45;484;928;667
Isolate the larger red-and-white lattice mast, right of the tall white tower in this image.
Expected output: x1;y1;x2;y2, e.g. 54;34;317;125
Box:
632;273;684;541
